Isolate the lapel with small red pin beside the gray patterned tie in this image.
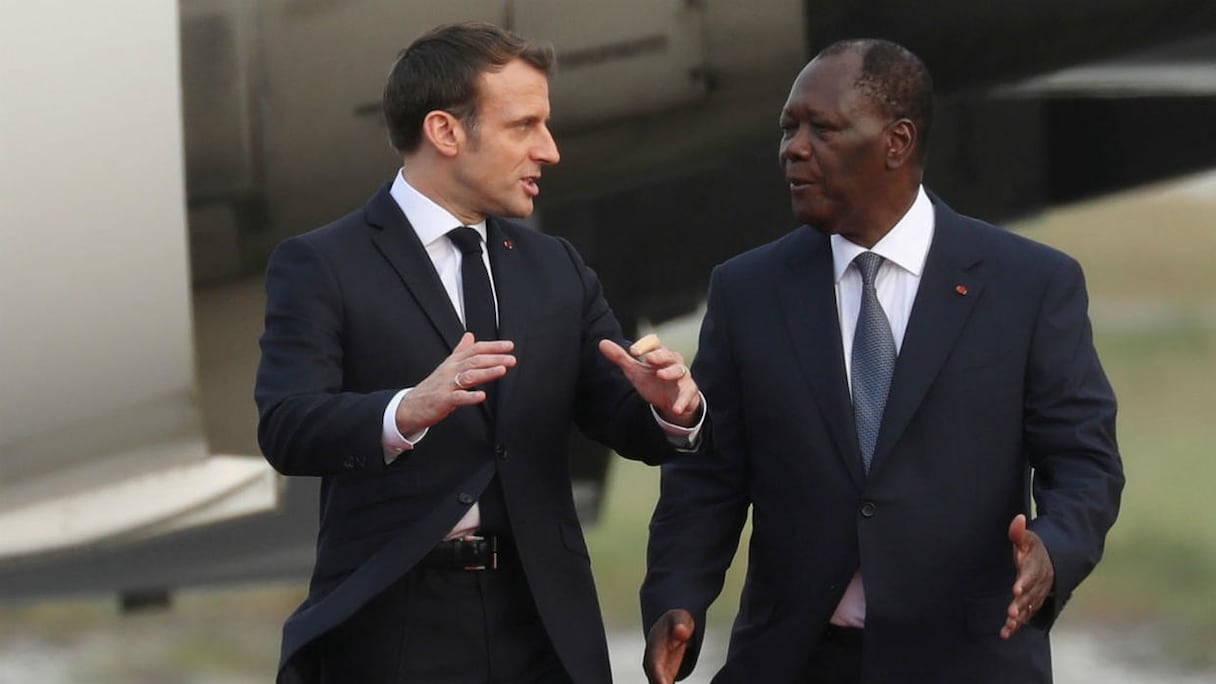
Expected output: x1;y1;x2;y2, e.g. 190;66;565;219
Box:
871;200;985;470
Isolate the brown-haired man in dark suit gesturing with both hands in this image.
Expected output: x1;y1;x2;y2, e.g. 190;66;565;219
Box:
257;23;704;684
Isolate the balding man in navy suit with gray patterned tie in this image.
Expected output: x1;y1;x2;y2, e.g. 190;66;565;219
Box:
641;40;1124;684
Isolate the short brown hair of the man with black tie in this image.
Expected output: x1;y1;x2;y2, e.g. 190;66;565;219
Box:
383;22;556;152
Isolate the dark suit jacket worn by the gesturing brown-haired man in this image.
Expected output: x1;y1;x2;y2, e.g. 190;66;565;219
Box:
255;186;695;683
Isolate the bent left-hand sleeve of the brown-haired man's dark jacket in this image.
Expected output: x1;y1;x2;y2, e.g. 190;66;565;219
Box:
254;237;395;476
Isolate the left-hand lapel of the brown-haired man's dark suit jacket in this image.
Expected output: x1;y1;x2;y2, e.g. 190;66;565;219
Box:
364;185;465;348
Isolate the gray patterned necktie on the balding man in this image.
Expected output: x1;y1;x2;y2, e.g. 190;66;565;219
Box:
852;252;895;472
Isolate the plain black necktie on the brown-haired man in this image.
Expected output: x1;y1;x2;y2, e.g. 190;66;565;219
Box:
447;225;507;534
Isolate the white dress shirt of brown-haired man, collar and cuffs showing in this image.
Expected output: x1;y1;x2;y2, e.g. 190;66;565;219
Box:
381;169;709;539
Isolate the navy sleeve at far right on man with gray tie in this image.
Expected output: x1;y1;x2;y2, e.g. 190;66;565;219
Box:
1025;251;1124;626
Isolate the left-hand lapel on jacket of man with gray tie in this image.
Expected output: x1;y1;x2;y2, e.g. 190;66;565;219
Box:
778;226;866;488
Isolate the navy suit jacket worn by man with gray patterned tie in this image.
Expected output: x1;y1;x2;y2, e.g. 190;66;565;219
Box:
642;198;1124;684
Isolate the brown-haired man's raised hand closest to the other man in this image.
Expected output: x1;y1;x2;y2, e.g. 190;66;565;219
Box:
599;335;700;427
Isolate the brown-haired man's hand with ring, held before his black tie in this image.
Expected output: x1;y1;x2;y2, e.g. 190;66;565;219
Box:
396;332;516;434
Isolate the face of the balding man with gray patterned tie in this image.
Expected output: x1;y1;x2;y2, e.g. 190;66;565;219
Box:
778;51;916;247
